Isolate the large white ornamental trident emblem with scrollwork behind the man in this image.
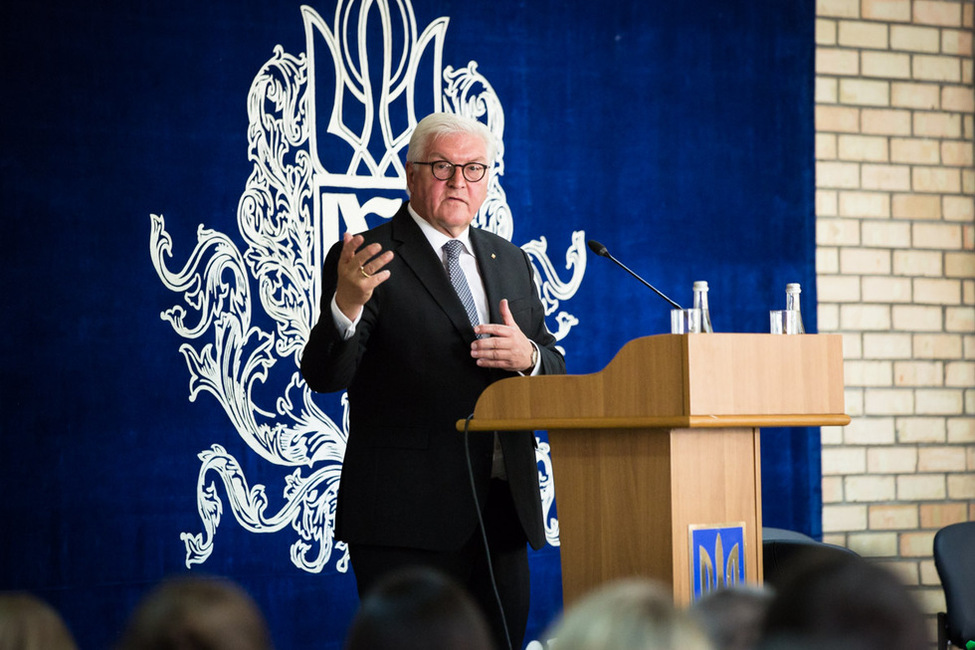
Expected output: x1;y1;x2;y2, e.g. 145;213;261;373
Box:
149;0;586;573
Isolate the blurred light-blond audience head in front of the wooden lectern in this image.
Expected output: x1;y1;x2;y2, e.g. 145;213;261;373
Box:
547;578;712;650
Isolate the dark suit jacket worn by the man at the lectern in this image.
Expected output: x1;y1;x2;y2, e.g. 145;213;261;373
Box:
301;203;565;550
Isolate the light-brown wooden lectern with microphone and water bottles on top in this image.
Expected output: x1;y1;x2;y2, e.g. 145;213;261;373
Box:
458;334;850;605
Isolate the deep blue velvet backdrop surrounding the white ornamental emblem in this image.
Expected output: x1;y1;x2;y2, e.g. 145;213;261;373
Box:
0;0;821;648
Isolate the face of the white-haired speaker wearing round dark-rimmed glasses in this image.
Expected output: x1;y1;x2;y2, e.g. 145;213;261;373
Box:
406;133;490;237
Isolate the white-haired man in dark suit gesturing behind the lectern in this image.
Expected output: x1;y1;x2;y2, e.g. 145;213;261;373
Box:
301;113;565;648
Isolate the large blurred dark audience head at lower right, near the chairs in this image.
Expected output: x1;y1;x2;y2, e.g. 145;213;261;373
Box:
761;548;929;650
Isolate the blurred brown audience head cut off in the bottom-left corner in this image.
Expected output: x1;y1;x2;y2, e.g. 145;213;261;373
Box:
0;592;78;650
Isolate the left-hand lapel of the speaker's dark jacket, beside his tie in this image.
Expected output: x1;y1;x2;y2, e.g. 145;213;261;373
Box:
392;203;480;340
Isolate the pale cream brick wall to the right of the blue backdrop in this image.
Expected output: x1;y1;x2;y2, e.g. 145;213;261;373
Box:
816;0;975;630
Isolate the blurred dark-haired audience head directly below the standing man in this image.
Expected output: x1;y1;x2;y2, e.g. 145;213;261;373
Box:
345;568;492;650
